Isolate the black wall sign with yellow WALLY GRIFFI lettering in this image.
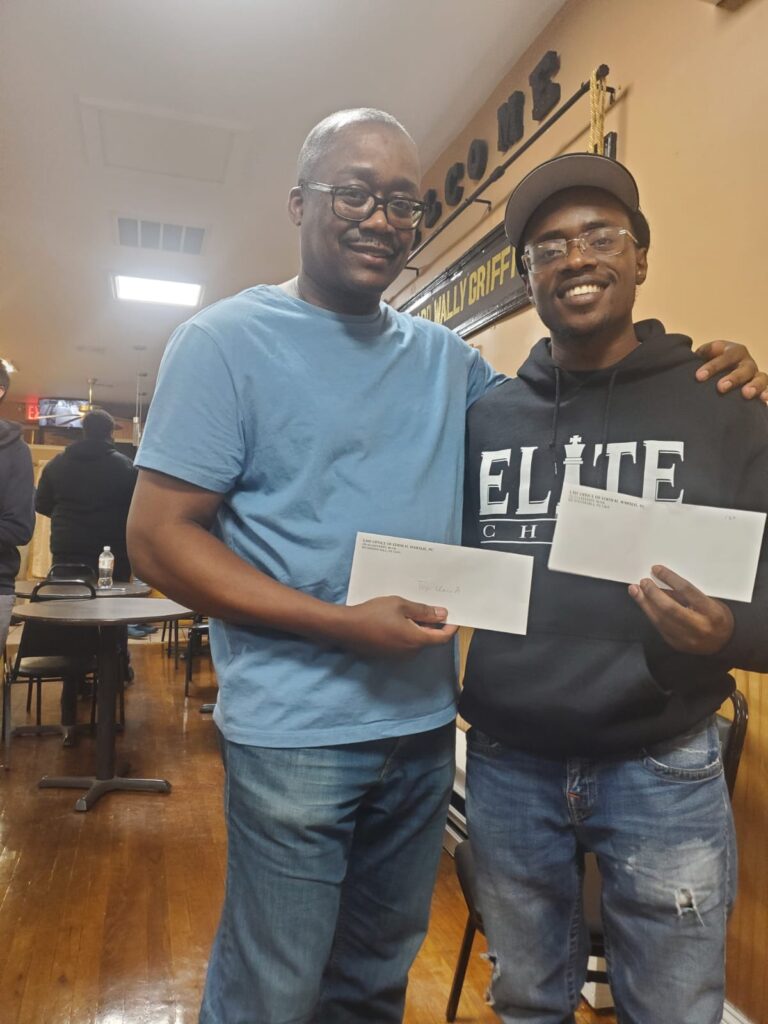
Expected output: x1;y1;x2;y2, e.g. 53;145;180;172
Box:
399;224;529;338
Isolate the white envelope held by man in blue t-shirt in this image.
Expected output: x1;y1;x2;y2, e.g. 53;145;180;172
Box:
347;534;534;633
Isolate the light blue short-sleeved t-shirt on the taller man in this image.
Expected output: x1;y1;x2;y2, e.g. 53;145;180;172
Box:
136;286;501;746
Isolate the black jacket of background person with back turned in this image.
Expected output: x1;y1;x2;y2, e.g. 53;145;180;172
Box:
36;438;136;563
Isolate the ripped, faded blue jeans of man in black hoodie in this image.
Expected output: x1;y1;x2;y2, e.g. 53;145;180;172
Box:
467;722;736;1024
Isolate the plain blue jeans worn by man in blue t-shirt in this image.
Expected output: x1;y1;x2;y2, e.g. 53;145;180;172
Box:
200;723;455;1024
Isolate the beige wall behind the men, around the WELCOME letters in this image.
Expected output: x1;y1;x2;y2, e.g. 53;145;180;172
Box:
403;0;768;1024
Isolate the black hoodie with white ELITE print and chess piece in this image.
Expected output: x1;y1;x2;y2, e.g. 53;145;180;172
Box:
460;321;768;757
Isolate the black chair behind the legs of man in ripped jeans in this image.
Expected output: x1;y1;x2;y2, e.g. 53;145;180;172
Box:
445;690;750;1021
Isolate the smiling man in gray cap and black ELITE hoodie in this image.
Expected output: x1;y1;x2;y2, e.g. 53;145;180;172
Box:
460;154;768;1024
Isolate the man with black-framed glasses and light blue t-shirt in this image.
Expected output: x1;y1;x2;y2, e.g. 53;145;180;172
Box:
129;110;765;1024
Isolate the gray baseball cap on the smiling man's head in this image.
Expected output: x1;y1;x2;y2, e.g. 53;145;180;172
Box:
504;153;640;249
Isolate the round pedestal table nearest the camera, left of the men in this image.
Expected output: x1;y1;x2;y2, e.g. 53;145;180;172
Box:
13;597;191;811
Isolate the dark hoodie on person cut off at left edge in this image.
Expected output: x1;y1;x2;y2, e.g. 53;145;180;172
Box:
0;420;35;594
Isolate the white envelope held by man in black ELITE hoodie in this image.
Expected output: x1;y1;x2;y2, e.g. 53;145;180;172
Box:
549;484;765;601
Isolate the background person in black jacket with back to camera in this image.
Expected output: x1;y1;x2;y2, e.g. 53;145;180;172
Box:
35;409;140;746
